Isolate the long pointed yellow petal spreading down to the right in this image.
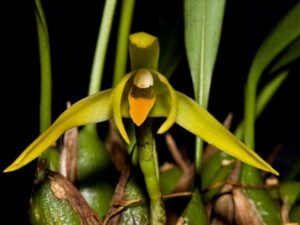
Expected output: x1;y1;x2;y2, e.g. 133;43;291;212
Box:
176;92;279;175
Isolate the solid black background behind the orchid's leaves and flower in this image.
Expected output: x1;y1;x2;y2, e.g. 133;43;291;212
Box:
0;0;300;224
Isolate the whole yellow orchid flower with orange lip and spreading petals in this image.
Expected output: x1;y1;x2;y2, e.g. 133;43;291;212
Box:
4;32;278;175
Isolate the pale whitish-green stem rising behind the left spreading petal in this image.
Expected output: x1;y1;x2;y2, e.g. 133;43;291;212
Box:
88;0;117;95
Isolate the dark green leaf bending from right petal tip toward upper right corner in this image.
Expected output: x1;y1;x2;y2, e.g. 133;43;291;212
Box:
244;3;300;148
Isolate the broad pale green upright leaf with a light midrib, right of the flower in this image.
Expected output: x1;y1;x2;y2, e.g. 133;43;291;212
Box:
184;0;225;108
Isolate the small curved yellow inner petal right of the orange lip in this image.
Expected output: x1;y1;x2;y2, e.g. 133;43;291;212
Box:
151;70;177;134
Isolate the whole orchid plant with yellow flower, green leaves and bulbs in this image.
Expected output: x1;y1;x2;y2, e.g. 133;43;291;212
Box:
4;0;300;225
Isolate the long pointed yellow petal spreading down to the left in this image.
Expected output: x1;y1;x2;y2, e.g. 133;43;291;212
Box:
4;89;112;172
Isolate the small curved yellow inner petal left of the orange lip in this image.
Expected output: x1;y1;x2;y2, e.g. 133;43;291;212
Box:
112;71;136;144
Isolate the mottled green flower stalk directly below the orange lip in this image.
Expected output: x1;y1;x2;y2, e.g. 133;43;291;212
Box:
136;118;166;225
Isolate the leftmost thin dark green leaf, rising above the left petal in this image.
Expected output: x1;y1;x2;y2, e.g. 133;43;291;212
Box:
34;0;52;132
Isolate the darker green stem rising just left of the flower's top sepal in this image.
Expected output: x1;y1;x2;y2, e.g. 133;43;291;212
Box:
113;0;135;86
